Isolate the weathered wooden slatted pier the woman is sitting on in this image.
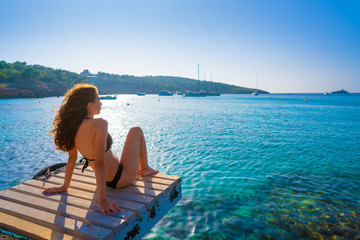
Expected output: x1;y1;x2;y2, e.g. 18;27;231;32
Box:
0;166;181;240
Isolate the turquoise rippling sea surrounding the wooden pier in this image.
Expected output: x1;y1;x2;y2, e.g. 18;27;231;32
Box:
0;94;360;239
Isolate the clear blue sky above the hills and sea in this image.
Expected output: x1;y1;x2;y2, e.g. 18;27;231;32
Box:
0;0;360;93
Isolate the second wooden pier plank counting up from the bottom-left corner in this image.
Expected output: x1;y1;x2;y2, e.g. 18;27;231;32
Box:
0;199;113;239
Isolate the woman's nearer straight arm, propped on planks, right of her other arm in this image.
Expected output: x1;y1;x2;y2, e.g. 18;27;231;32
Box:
94;119;120;216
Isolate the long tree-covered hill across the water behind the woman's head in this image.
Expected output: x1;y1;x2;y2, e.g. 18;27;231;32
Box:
0;61;267;98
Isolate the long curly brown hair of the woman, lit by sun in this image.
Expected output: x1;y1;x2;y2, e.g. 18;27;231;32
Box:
50;83;98;152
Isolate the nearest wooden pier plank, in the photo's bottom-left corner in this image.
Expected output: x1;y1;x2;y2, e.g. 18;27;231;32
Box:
0;212;79;240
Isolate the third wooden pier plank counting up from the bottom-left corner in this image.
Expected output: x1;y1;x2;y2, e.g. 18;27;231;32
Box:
0;190;126;234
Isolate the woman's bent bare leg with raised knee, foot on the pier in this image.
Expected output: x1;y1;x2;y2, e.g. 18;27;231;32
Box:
117;127;159;187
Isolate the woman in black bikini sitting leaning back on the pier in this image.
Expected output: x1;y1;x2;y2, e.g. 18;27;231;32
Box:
43;84;159;215
